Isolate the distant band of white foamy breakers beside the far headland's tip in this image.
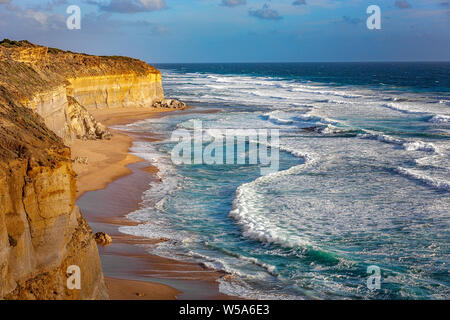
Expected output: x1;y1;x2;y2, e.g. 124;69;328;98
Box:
160;67;373;111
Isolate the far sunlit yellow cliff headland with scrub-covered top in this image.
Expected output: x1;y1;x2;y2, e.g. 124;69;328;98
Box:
0;41;165;145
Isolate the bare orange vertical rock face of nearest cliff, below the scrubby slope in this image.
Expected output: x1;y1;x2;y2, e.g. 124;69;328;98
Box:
0;158;108;299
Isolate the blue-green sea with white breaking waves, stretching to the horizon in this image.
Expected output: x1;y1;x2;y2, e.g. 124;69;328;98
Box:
115;63;450;299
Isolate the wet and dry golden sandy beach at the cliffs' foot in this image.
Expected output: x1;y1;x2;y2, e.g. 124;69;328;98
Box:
72;108;236;300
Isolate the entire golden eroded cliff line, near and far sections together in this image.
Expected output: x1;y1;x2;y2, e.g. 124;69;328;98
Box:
0;42;170;299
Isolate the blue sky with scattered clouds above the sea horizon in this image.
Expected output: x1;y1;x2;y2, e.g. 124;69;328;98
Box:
0;0;450;63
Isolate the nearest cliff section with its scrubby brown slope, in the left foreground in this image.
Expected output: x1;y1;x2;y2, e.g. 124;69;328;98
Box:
0;98;107;299
